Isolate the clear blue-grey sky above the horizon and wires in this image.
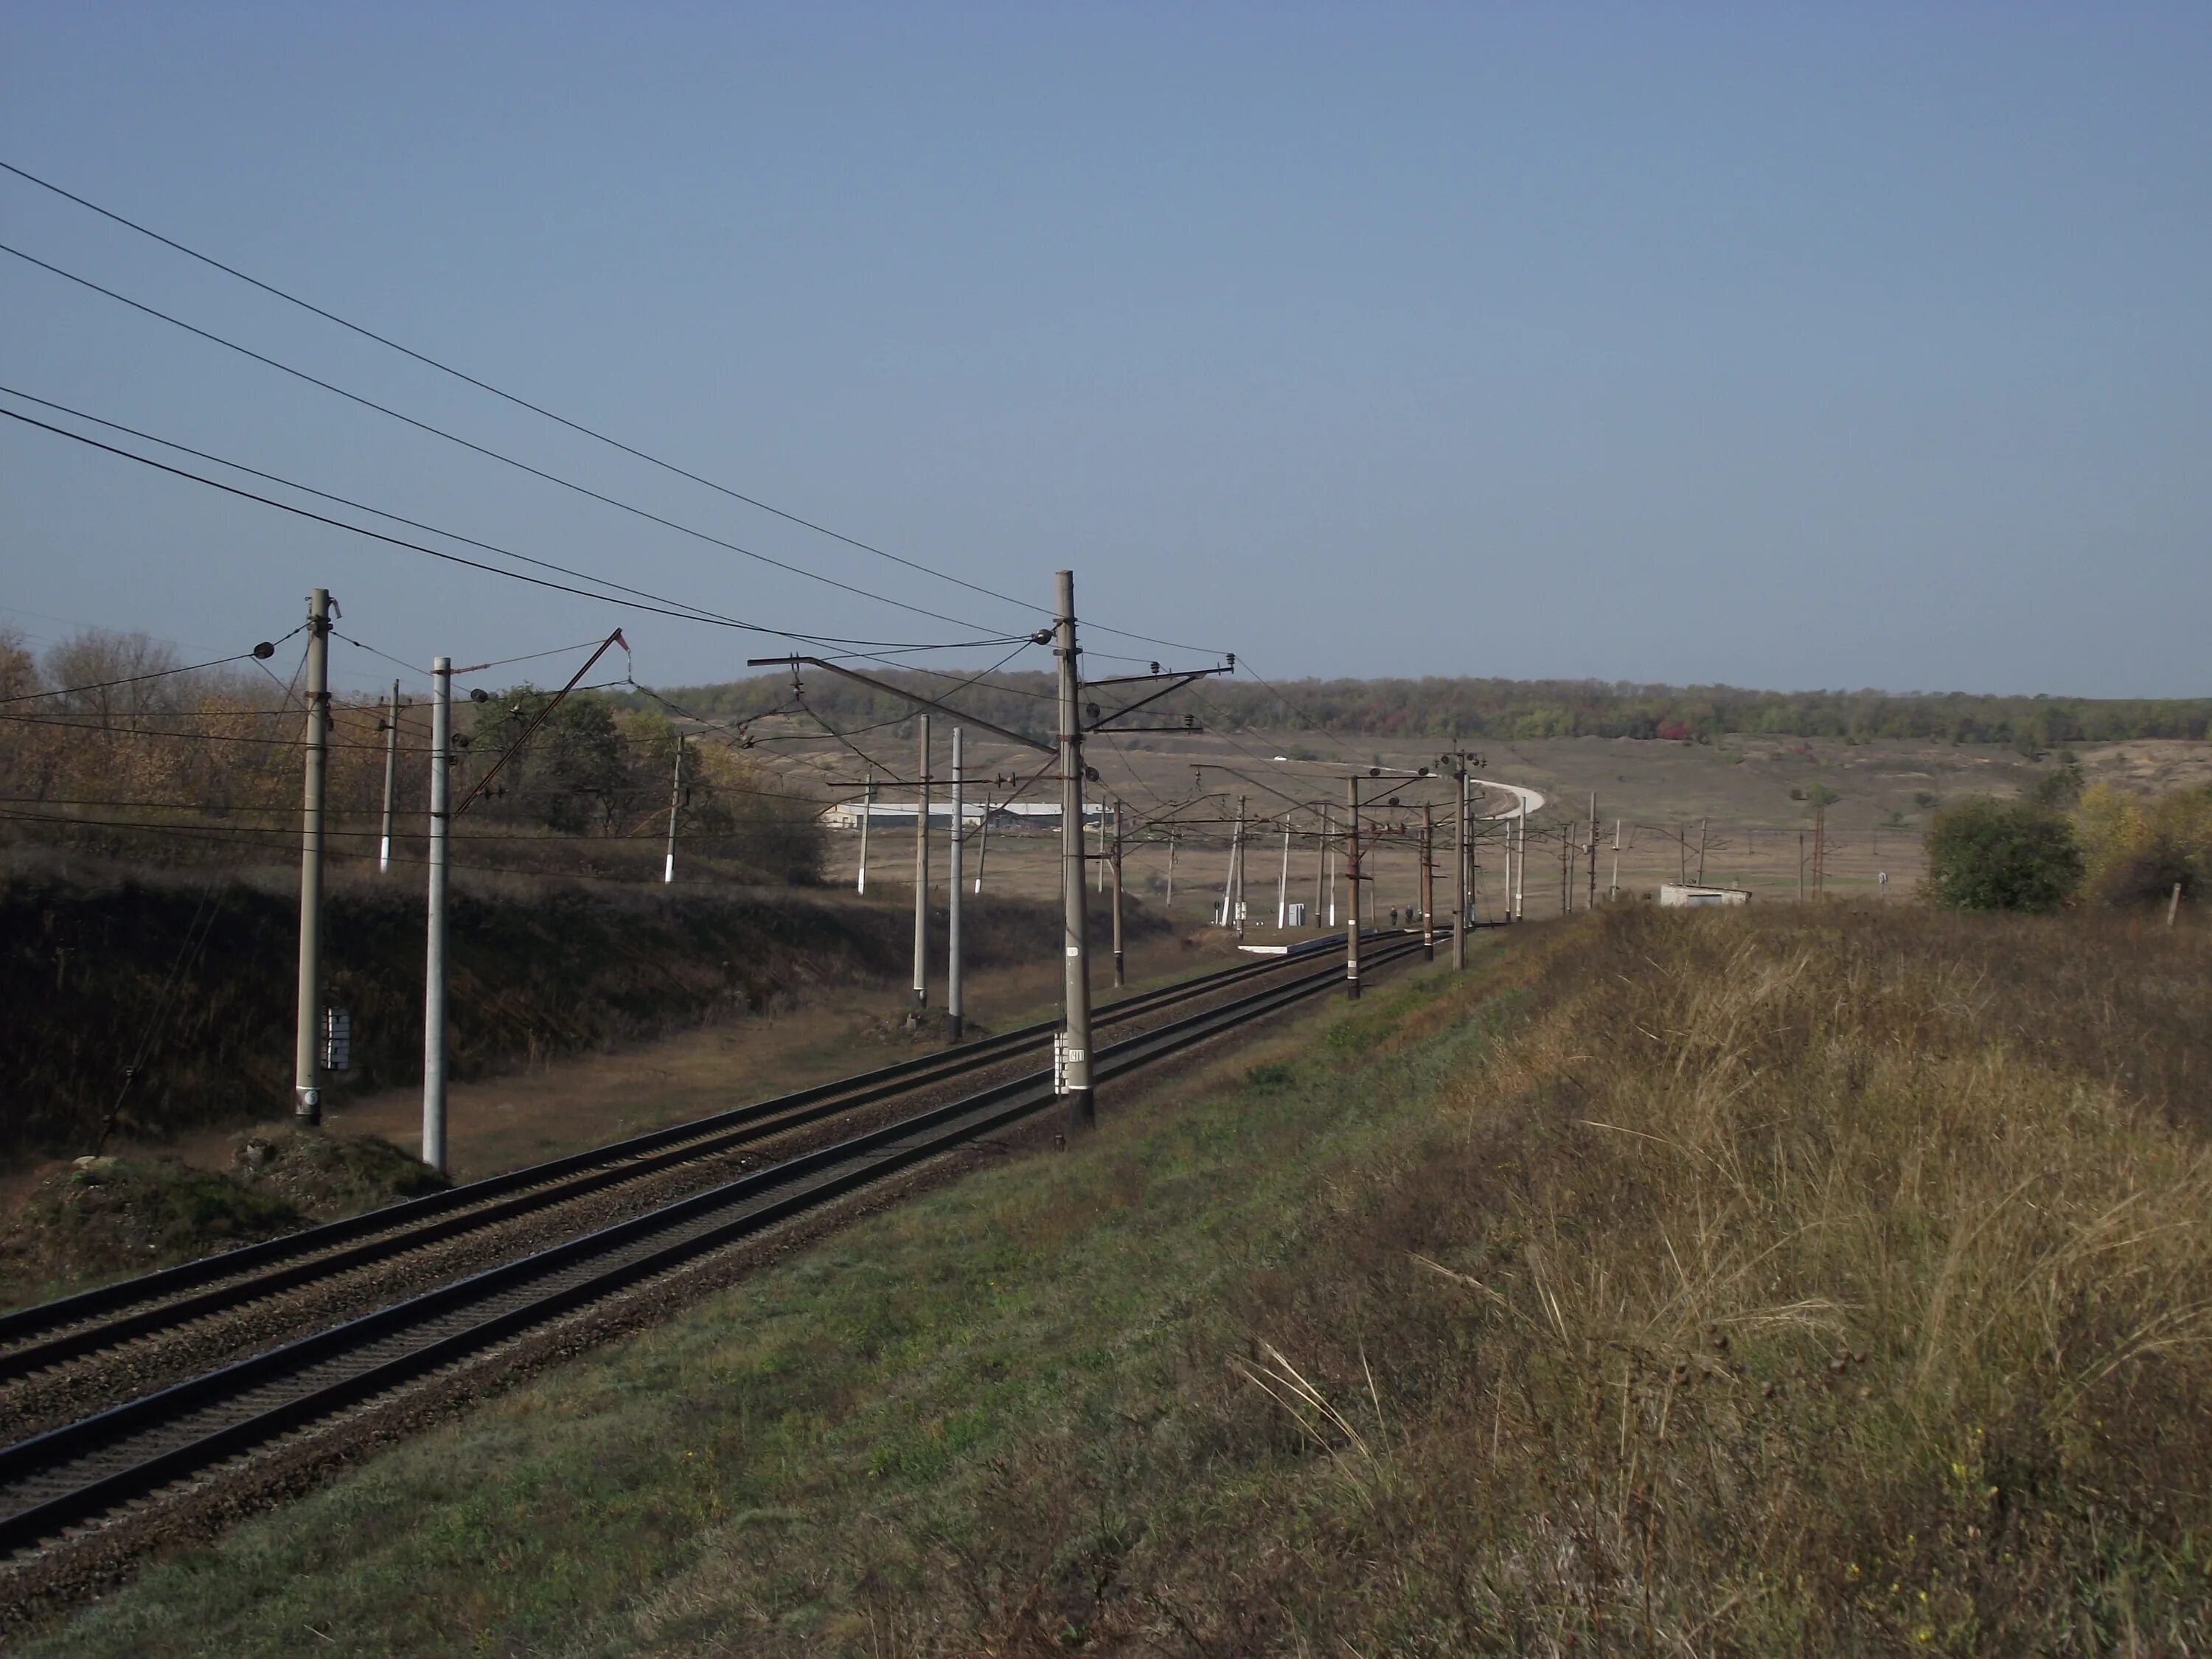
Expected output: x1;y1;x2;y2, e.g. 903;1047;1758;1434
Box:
0;0;2212;695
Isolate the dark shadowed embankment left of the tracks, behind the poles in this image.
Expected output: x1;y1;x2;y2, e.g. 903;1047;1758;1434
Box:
0;876;1161;1161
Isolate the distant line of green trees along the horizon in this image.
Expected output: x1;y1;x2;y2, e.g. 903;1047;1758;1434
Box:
628;670;2212;750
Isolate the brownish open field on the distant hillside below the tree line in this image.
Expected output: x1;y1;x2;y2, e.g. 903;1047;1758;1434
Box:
761;732;2212;916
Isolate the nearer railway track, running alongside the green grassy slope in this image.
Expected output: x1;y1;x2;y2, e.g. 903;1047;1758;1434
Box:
0;938;1418;1555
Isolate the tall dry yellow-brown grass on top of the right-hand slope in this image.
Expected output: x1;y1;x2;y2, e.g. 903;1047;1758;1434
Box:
1183;909;2212;1652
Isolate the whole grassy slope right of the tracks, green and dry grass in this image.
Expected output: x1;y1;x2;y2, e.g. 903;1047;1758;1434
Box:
21;909;2212;1657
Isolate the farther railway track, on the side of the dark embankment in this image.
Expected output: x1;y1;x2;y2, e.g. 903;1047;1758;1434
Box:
0;936;1340;1382
